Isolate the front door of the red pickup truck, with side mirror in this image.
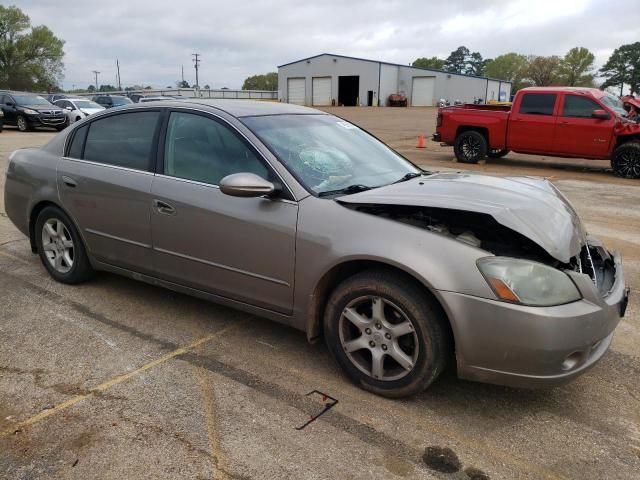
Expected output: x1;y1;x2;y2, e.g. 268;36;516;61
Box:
555;94;615;158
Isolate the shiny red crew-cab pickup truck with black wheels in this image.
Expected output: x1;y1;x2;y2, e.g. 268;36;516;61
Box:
433;87;640;178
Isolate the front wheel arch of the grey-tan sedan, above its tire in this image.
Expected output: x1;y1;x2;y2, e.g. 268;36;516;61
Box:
306;259;455;355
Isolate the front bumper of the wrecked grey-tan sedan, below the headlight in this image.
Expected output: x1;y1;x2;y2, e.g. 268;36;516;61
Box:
439;256;629;388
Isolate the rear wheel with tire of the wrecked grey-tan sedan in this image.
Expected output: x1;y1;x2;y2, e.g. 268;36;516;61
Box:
33;206;94;285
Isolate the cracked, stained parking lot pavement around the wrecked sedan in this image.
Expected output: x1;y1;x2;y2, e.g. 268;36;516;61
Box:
0;108;640;480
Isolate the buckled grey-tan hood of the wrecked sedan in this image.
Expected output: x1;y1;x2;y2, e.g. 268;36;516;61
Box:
337;173;585;263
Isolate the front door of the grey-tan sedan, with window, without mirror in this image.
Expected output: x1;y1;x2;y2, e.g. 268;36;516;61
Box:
151;111;298;313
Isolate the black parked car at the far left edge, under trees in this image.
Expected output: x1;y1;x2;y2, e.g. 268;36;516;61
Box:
0;91;67;132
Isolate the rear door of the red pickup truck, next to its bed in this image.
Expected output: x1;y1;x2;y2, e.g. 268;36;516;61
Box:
507;92;559;154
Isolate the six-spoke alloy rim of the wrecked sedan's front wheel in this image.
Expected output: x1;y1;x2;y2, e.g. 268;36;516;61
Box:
339;296;419;381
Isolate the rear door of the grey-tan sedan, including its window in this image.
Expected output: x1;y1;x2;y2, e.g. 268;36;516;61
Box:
57;109;161;273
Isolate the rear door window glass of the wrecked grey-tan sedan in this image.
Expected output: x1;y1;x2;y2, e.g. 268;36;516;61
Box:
84;112;160;170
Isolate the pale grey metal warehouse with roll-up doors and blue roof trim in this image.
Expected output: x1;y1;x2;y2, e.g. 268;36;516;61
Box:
278;53;511;107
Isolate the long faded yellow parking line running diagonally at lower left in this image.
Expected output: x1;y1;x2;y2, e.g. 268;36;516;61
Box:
0;323;240;438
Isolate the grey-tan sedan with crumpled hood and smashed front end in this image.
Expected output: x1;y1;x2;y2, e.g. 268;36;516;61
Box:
5;100;628;397
